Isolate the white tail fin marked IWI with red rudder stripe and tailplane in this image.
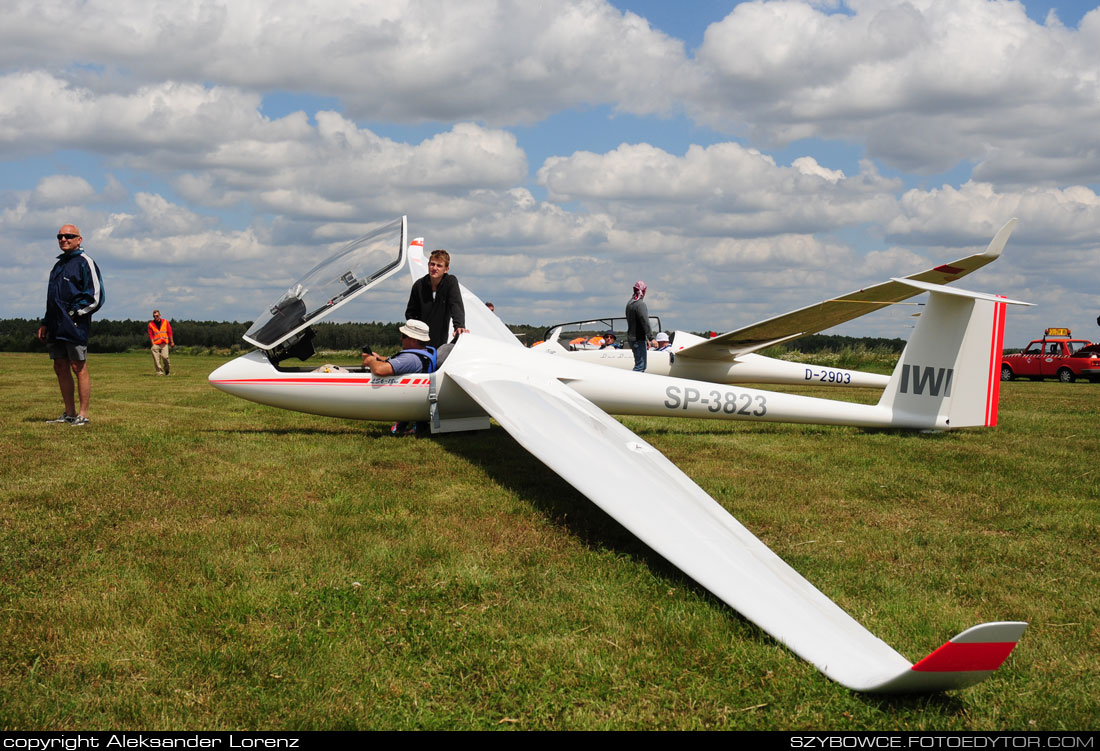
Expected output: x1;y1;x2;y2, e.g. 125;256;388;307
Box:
879;279;1030;430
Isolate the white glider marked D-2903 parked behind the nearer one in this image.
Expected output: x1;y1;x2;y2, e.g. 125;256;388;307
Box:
528;219;1016;388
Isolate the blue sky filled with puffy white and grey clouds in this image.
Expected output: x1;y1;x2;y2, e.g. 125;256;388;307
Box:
0;0;1100;346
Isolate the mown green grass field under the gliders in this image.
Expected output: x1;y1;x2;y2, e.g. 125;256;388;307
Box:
0;354;1100;730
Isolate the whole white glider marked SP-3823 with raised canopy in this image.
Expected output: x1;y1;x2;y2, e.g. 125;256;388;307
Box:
210;218;1027;693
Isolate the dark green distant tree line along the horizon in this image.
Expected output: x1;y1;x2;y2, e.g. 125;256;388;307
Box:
0;318;905;353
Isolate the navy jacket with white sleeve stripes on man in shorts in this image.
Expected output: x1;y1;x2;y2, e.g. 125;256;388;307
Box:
42;247;105;344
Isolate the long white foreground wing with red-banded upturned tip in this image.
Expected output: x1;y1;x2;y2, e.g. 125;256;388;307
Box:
446;341;1025;693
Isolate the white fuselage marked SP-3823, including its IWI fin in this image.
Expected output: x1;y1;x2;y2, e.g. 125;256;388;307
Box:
210;283;1007;430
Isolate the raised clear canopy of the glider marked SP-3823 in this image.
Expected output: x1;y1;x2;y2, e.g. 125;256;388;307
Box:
244;217;408;350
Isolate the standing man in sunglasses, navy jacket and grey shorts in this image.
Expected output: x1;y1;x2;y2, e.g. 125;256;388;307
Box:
39;224;103;427
